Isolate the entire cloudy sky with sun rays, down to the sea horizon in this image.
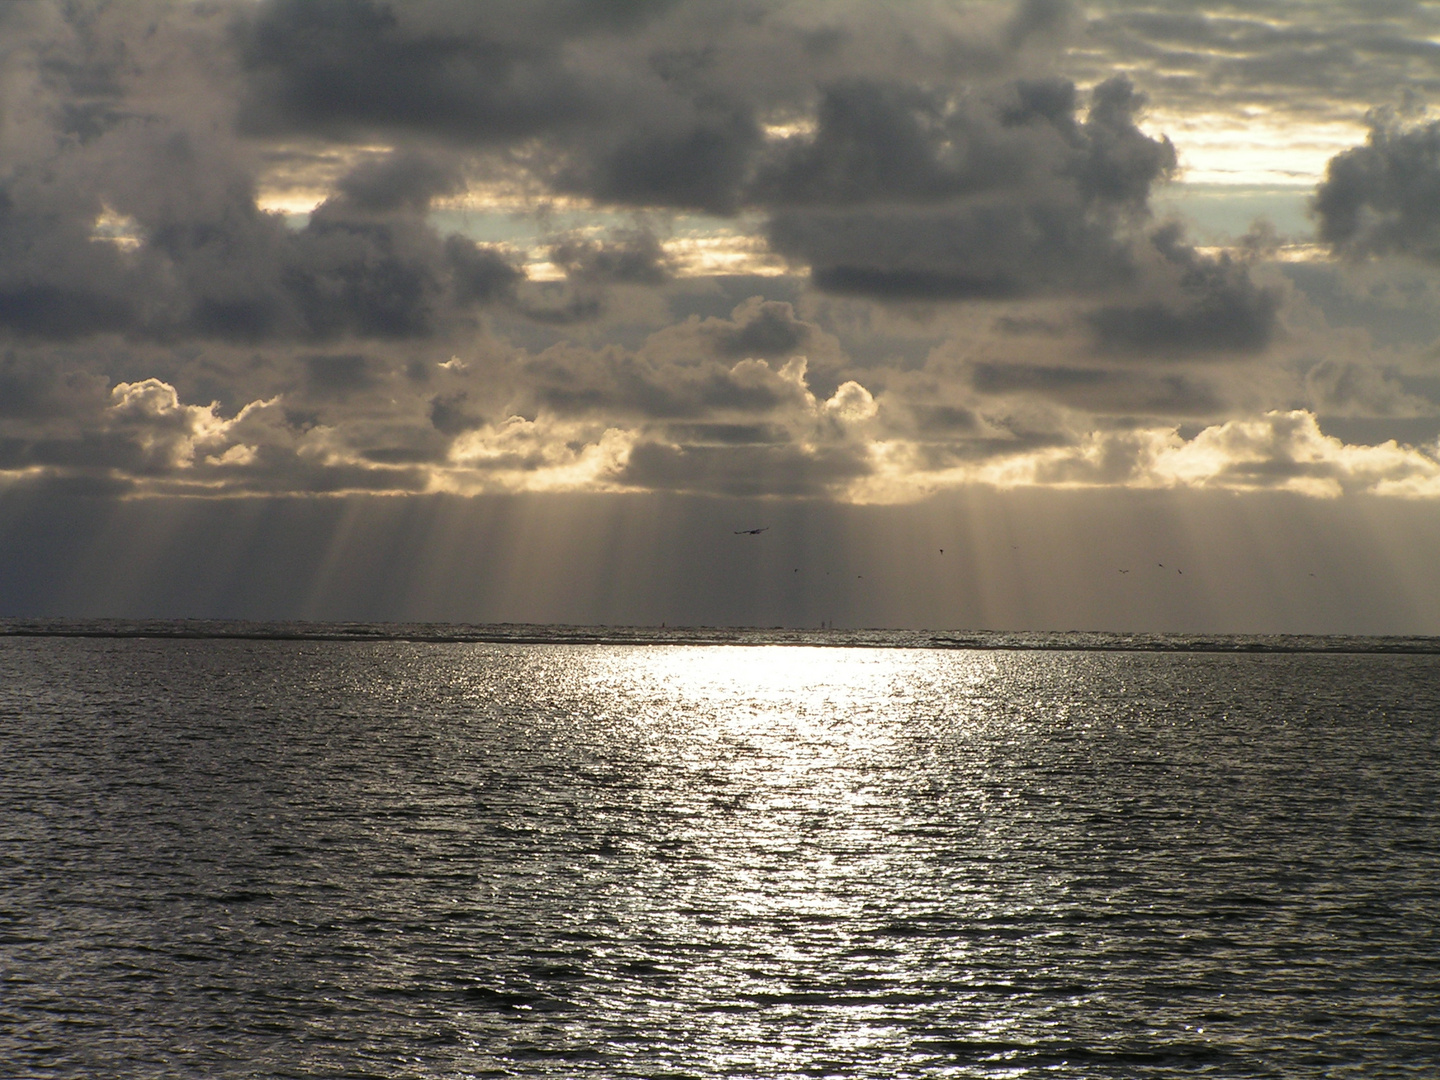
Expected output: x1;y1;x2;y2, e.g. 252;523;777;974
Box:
0;0;1440;634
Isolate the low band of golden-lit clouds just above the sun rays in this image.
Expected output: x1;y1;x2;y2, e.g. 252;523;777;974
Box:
0;356;1440;503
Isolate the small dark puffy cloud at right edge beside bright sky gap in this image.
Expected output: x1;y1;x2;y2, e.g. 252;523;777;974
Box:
1313;114;1440;262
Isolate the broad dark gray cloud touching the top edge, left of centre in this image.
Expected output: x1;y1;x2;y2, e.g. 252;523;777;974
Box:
236;0;1067;213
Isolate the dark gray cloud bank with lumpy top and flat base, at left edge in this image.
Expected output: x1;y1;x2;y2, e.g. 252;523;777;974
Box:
0;131;523;341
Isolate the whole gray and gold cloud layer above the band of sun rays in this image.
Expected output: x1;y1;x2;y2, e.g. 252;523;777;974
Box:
0;0;1440;500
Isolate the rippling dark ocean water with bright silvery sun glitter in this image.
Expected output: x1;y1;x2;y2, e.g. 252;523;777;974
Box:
0;625;1440;1077
